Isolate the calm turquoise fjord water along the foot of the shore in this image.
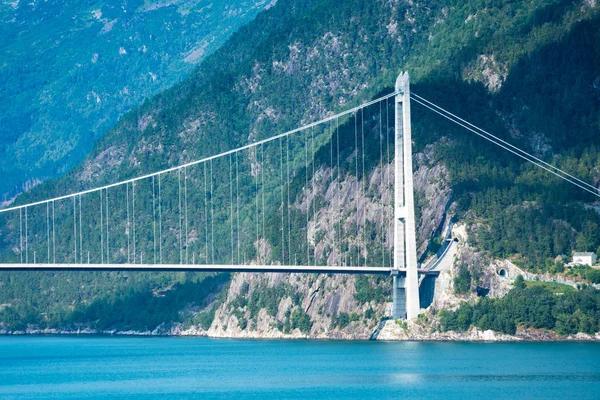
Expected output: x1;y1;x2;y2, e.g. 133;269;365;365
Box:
0;337;600;400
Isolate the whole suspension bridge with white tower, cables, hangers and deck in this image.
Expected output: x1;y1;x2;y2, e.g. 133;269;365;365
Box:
0;73;600;319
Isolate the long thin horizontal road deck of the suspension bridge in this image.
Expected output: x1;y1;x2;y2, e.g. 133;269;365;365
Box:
0;264;439;275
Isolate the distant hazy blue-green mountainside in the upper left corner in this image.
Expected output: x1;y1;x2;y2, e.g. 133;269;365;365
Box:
0;0;269;200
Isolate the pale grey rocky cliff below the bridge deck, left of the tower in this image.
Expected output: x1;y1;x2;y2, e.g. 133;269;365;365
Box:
206;273;382;339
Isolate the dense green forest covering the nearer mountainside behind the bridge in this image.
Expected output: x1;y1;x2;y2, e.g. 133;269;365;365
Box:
0;0;600;332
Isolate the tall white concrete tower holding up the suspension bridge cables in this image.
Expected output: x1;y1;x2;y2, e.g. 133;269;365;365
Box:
392;72;420;319
